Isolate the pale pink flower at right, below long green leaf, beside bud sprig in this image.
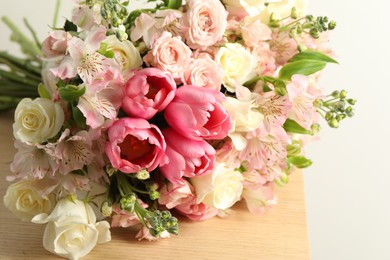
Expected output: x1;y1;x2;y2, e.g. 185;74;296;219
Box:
287;75;321;130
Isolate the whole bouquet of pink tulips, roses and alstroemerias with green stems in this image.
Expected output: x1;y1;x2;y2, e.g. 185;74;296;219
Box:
0;0;356;259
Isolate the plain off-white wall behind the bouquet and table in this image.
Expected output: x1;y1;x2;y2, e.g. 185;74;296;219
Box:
0;0;390;260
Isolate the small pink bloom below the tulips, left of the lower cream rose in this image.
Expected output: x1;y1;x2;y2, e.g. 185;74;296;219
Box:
158;179;194;209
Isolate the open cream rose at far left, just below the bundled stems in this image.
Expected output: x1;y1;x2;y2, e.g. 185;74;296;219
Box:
12;98;64;144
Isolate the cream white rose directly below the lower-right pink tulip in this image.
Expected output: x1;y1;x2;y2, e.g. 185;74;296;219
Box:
191;163;244;210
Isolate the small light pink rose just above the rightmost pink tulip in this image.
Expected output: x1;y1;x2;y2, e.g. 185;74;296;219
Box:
183;53;223;91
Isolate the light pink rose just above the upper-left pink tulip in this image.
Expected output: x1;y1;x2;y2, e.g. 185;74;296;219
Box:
144;31;192;79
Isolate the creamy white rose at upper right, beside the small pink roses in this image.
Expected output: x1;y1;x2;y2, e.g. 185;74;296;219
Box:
215;43;257;92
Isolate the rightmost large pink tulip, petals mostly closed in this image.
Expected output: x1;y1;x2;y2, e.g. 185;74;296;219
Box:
164;86;231;140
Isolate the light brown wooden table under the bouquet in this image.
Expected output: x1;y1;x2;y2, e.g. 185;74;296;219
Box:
0;112;310;260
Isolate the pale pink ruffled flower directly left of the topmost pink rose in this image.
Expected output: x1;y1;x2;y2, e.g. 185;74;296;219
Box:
130;9;183;48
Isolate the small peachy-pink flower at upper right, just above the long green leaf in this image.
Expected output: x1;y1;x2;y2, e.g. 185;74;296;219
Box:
269;31;298;65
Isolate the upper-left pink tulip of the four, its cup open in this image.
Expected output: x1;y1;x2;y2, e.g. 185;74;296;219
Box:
122;68;176;120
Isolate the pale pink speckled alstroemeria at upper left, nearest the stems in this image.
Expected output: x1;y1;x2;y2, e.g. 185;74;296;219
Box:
51;26;110;84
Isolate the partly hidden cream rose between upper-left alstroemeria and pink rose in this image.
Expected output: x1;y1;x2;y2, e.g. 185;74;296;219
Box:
104;35;142;71
